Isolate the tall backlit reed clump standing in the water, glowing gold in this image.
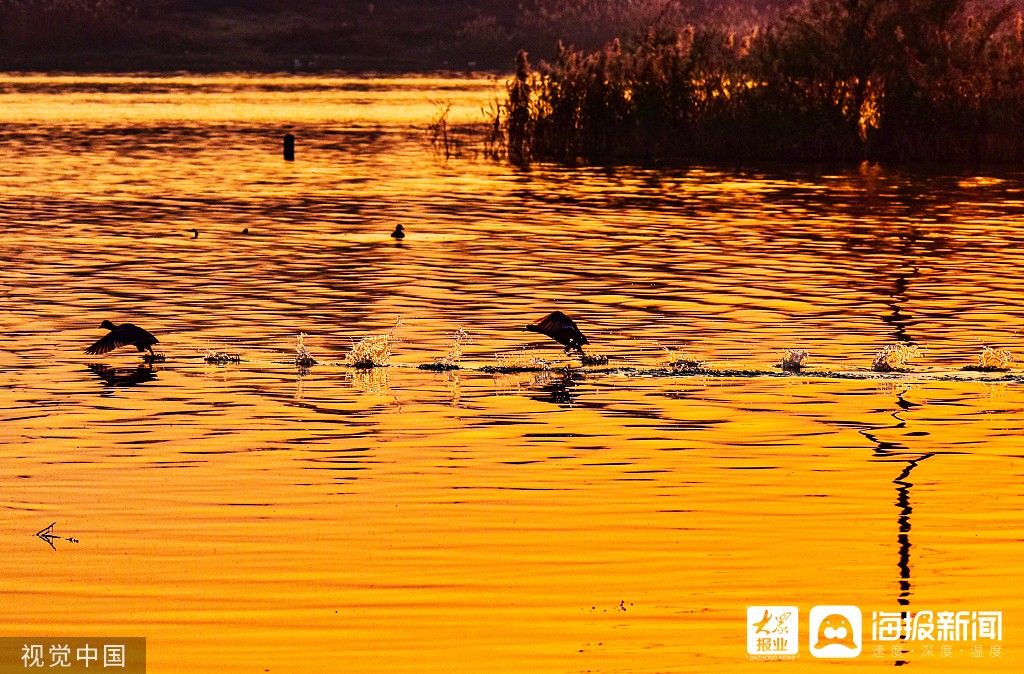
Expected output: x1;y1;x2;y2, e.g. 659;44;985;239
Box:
496;0;1024;164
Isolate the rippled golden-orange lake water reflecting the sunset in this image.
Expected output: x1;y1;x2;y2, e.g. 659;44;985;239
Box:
0;76;1024;673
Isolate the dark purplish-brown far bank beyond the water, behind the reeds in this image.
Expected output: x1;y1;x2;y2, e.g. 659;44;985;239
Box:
0;0;774;72
